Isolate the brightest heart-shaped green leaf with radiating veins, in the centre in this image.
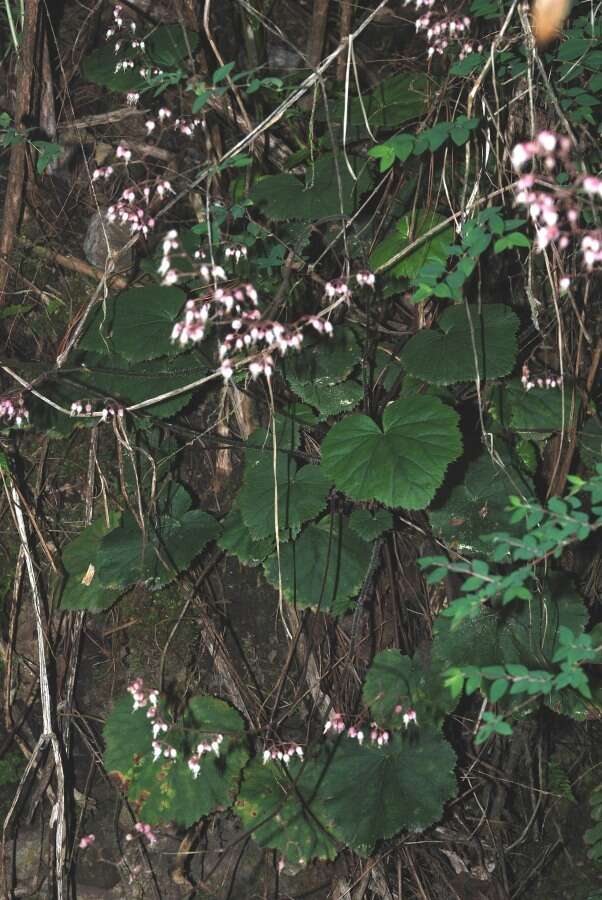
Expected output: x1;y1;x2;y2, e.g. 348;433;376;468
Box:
322;397;462;509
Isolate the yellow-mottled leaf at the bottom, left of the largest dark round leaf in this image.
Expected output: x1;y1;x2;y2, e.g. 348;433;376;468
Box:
235;759;338;865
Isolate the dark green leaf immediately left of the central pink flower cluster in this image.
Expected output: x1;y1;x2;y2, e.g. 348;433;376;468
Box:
80;284;186;362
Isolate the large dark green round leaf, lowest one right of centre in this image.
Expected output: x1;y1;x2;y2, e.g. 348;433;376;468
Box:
319;727;457;852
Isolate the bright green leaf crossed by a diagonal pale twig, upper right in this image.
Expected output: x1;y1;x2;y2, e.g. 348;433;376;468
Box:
370;210;453;278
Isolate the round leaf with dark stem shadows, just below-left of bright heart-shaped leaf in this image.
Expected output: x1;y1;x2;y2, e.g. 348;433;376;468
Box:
264;518;371;616
